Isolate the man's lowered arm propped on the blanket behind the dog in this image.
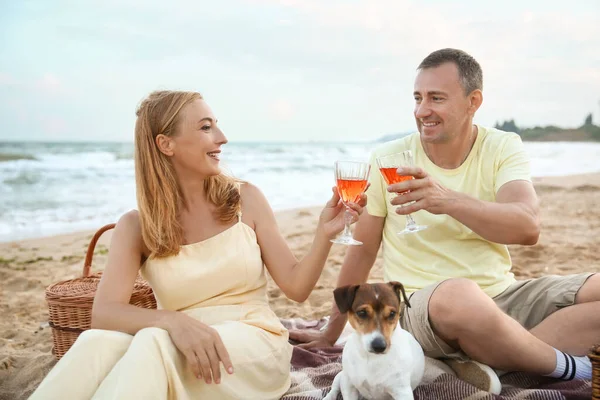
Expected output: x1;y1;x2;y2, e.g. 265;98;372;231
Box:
290;213;385;348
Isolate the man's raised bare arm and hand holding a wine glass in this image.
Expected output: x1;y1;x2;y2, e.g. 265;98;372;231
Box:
388;167;540;245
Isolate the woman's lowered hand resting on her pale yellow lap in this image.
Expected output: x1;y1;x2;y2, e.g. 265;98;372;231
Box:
167;312;233;383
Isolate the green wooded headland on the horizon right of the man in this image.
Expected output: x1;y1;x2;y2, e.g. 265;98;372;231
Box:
495;114;600;142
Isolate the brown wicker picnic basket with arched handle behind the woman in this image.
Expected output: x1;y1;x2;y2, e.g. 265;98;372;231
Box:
46;224;156;359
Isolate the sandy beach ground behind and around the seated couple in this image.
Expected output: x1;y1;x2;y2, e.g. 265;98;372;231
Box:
0;174;600;400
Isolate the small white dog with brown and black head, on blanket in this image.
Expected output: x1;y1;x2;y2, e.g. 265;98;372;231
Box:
325;282;425;400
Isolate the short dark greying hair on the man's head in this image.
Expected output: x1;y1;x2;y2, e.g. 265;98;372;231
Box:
417;49;483;95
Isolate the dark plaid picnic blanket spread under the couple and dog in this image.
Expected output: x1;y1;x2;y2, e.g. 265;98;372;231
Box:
282;318;592;400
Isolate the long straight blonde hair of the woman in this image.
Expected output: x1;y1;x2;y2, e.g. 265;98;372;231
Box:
135;91;240;257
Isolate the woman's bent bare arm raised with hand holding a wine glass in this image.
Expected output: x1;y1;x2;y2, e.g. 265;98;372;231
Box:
242;184;366;302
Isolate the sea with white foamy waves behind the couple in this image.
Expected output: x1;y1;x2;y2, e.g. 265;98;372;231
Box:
0;141;600;242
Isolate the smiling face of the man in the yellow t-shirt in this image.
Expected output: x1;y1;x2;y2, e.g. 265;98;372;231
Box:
414;62;473;143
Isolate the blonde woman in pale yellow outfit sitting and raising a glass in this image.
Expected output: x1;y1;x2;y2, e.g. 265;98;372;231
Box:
31;91;366;400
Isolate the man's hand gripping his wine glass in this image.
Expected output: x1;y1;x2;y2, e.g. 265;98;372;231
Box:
387;167;455;215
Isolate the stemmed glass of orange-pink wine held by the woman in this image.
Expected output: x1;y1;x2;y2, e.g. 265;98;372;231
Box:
331;161;371;246
